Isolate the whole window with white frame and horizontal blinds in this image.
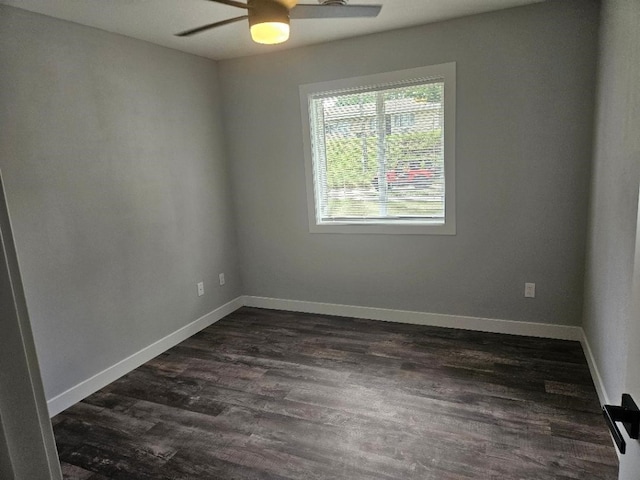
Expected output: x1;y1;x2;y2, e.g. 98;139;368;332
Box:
300;63;455;235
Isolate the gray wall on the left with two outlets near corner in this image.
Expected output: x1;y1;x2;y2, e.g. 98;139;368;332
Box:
0;6;242;398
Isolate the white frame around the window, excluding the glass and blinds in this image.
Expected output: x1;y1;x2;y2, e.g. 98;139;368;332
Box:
299;62;456;235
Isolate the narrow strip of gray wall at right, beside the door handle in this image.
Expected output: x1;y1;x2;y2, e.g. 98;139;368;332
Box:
584;0;640;404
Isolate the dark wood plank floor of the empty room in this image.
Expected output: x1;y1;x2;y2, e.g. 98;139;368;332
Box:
53;308;618;480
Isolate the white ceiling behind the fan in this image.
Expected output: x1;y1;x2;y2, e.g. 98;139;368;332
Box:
0;0;544;60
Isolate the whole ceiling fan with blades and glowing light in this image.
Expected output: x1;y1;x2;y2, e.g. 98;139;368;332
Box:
176;0;382;45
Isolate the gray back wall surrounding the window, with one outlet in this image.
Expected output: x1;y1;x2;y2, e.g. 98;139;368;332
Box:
220;0;598;325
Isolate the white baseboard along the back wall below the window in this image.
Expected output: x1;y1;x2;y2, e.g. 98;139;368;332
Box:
243;296;584;341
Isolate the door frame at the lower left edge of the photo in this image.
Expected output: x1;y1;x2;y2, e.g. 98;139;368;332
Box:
0;171;62;480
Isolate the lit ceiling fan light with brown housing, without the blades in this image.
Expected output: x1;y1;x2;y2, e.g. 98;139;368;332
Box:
248;0;289;45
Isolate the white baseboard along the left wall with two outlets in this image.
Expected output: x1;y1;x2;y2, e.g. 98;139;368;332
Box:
47;297;243;417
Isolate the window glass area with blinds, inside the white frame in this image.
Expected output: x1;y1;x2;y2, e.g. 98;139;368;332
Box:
310;79;445;223
